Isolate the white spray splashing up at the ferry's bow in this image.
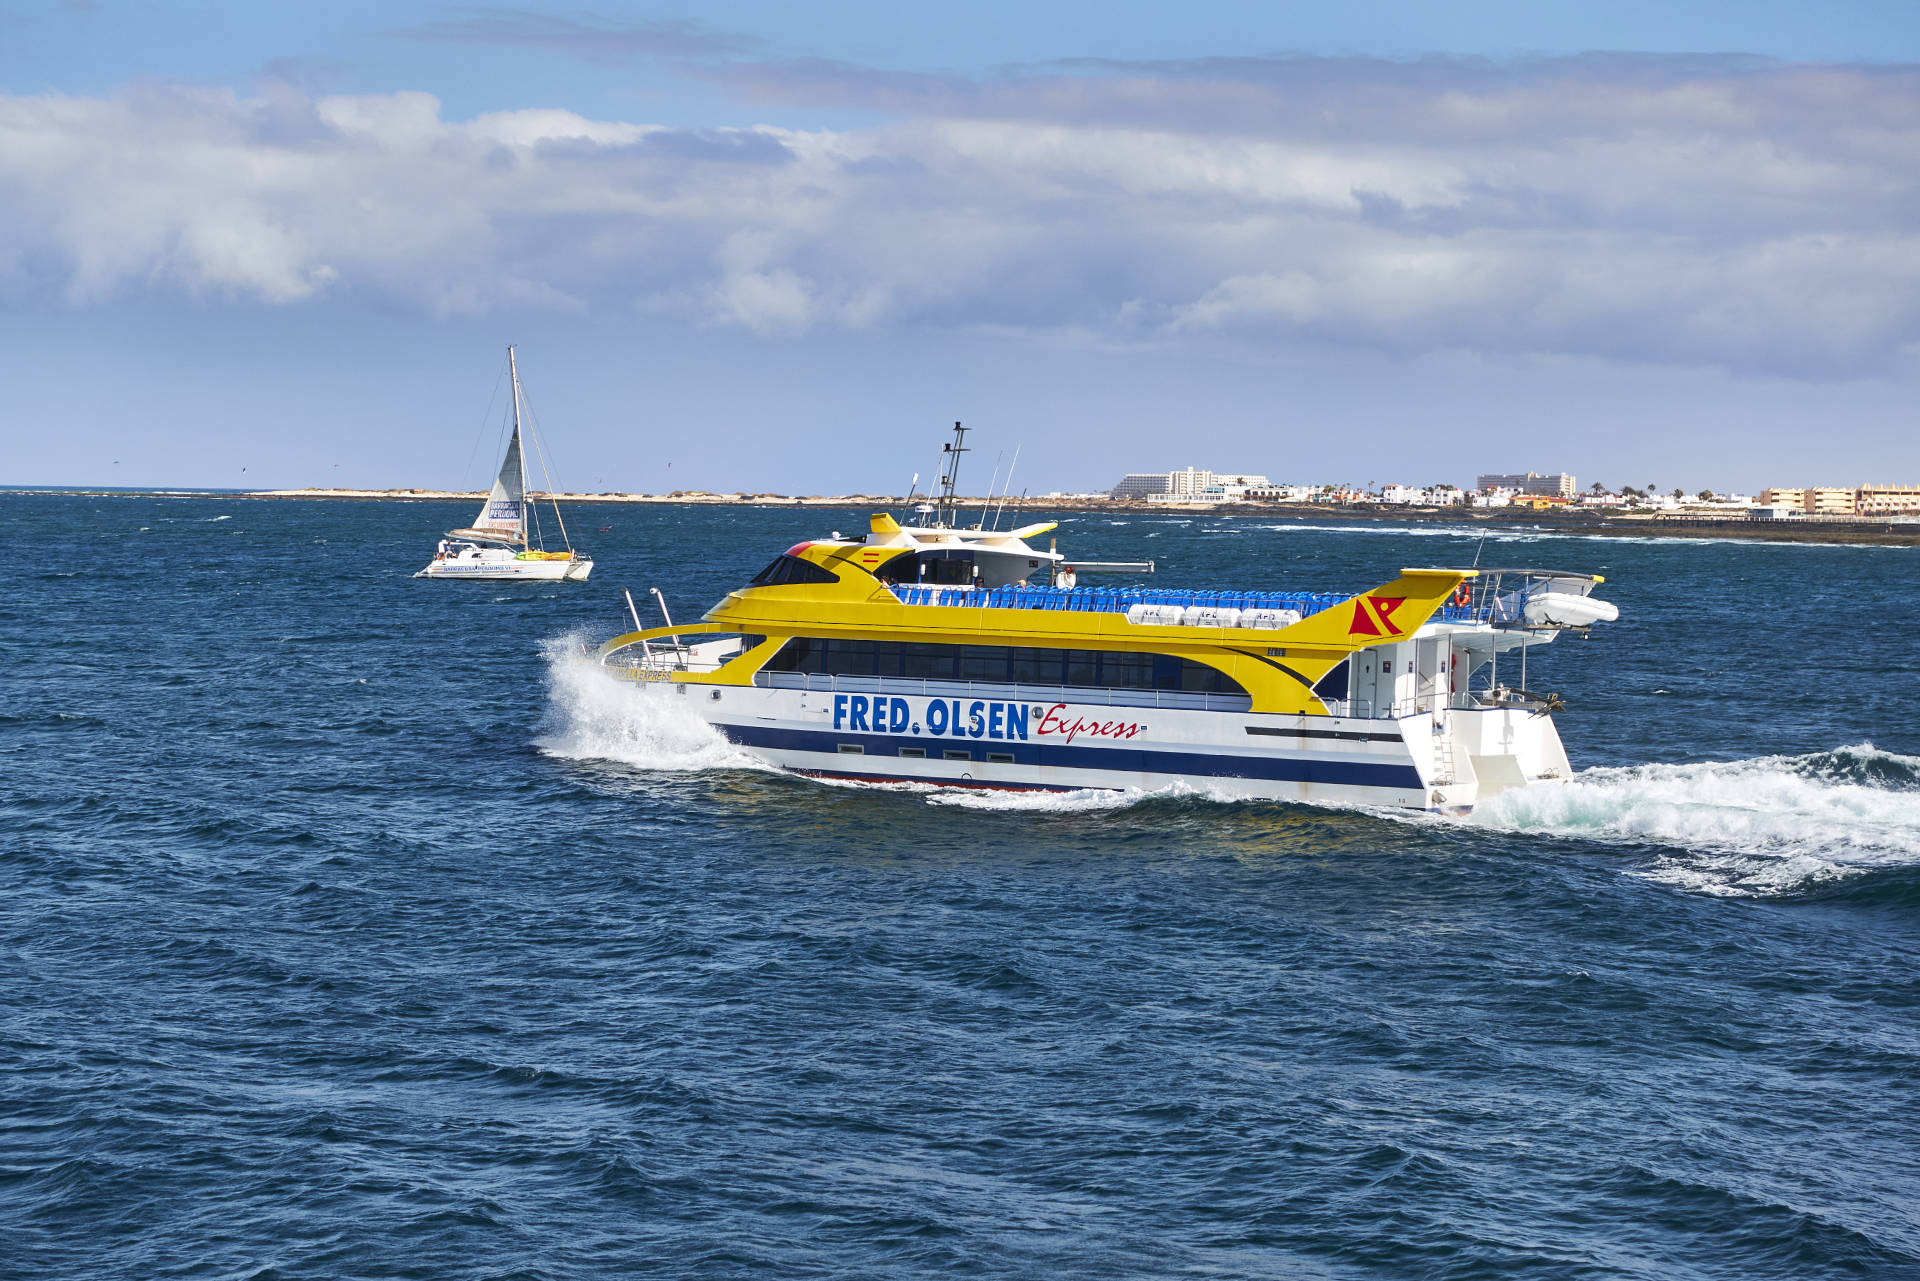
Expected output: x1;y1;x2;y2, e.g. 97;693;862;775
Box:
534;632;768;770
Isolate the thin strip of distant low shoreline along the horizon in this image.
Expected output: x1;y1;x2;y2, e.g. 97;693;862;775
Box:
0;486;1920;547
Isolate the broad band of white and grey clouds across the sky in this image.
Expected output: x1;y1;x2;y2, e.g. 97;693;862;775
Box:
0;56;1920;376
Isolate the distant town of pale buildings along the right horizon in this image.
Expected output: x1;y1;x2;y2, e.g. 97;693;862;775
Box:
1090;467;1920;520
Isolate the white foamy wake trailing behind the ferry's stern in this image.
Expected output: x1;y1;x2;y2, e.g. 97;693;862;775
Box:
1471;743;1920;895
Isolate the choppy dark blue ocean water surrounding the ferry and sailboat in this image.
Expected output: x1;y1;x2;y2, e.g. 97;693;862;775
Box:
0;495;1920;1281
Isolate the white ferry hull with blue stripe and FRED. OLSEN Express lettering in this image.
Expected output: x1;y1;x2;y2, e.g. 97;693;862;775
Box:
628;670;1571;814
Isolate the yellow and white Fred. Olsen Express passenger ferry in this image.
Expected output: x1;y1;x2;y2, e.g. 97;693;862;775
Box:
599;430;1619;814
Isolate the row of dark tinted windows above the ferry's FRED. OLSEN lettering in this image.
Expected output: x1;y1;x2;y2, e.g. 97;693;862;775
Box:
762;636;1246;693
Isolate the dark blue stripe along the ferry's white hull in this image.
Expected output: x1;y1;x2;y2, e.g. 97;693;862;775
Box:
714;722;1427;791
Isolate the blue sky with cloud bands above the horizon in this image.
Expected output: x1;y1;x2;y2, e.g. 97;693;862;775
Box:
0;0;1920;494
